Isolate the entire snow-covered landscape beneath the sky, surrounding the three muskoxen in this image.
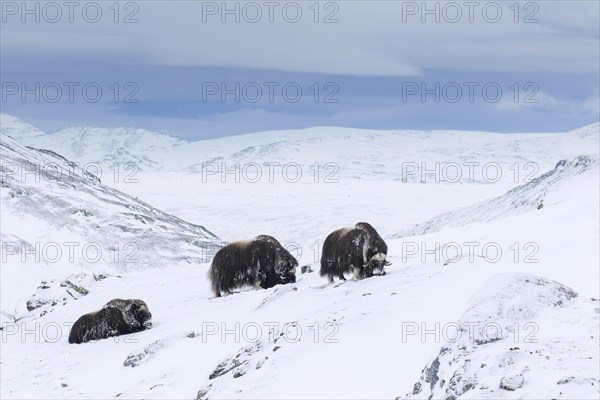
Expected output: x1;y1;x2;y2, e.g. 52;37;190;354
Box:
0;115;600;399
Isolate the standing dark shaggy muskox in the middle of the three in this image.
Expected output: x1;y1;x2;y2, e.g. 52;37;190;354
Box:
208;235;298;297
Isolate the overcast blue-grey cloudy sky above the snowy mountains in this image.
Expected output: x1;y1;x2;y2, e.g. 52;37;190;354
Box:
0;0;600;139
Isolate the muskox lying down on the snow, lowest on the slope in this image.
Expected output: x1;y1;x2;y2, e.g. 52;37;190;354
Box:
69;299;152;343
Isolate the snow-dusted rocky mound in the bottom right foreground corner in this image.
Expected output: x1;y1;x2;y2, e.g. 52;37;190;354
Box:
407;274;600;399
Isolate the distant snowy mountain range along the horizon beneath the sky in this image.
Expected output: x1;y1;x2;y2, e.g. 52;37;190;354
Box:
3;113;600;183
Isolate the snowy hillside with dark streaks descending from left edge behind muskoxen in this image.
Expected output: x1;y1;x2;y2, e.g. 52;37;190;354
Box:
0;134;219;320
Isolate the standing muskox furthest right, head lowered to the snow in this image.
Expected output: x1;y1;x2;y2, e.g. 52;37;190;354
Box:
321;222;391;283
